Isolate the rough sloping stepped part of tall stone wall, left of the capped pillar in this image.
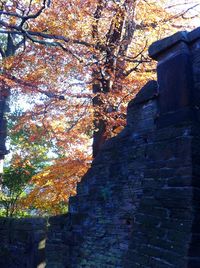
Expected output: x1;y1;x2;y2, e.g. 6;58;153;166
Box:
65;82;157;267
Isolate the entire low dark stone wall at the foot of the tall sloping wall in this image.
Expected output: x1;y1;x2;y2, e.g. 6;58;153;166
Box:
0;215;69;268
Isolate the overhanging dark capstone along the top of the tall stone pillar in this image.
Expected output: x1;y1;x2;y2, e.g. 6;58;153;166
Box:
149;27;200;60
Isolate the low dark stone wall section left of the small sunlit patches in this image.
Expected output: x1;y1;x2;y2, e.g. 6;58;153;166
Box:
0;218;46;268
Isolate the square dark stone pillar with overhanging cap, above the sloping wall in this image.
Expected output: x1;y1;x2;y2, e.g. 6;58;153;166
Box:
149;32;194;128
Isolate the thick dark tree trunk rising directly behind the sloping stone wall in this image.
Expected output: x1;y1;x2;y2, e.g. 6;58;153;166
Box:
93;0;137;157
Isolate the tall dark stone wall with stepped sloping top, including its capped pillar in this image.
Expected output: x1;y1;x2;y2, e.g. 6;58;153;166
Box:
47;29;200;268
